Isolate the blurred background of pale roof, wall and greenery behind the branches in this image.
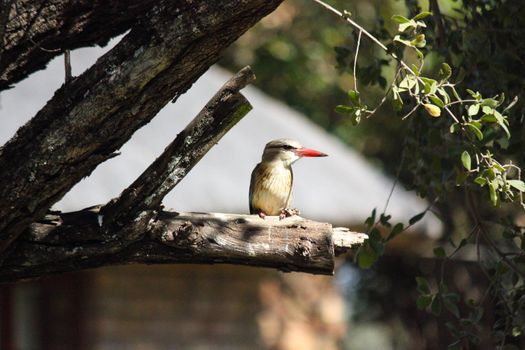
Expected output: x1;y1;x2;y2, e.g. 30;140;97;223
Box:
0;0;523;350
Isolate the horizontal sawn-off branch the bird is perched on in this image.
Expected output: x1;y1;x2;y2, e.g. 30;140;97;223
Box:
0;207;366;282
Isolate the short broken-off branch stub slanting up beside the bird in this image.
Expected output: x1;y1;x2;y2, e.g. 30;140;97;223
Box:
102;67;255;225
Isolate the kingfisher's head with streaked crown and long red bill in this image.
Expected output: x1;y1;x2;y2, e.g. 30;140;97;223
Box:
262;139;327;166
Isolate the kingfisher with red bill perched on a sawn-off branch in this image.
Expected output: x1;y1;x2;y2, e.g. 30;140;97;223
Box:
250;139;327;219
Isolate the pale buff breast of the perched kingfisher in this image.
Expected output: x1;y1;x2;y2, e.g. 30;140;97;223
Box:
251;165;293;215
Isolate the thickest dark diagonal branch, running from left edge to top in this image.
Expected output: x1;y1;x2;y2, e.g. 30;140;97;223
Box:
0;0;281;252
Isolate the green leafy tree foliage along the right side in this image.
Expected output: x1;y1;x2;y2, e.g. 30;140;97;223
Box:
223;0;525;349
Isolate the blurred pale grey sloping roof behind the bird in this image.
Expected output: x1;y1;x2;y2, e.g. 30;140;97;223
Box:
0;39;441;237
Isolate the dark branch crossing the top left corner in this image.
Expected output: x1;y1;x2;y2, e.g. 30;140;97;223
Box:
0;0;157;90
